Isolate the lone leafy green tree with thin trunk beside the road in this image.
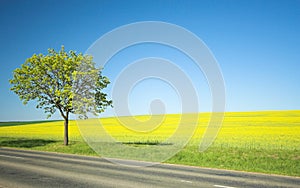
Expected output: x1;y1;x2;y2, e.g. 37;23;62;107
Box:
10;46;112;145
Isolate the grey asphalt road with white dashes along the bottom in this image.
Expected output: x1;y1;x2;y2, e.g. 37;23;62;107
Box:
0;148;300;188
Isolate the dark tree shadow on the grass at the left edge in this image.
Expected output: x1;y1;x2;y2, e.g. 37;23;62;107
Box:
0;138;57;148
